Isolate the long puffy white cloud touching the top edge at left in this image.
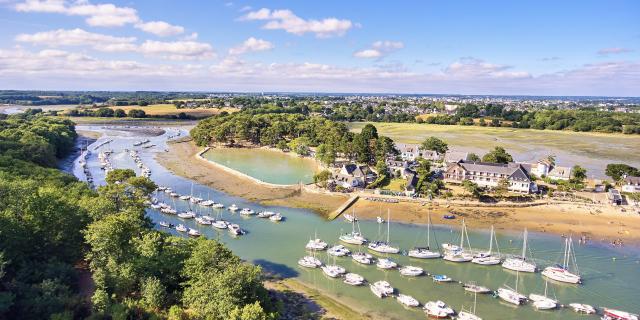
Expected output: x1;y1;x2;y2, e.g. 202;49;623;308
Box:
15;0;184;36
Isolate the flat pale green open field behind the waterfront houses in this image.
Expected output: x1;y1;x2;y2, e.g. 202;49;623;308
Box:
349;122;640;179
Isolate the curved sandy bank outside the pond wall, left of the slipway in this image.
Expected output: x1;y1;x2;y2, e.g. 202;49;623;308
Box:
157;140;347;215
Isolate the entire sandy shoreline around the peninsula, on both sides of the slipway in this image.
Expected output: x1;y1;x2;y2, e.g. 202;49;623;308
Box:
158;142;640;243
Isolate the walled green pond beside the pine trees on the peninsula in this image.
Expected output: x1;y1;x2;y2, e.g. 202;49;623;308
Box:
203;148;316;184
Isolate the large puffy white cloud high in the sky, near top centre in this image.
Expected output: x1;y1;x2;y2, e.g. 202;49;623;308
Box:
240;8;354;38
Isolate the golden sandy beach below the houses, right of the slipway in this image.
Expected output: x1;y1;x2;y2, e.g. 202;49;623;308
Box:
351;197;640;243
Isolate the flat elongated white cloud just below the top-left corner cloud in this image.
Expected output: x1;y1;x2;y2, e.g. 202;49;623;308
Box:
15;28;136;47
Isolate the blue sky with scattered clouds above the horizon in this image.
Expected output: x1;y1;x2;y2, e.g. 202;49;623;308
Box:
0;0;640;96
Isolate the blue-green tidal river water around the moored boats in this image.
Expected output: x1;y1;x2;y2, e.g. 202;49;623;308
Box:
73;126;640;319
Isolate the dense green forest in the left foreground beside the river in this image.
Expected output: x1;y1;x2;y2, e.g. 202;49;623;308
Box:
0;114;279;320
